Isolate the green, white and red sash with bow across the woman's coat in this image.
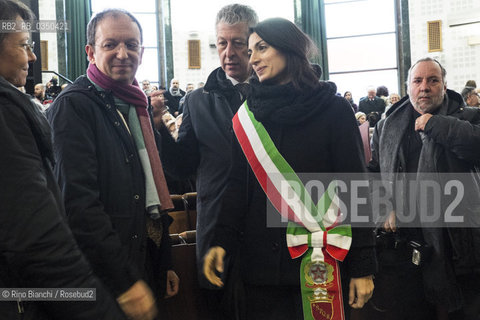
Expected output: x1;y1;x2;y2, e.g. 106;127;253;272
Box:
233;102;352;320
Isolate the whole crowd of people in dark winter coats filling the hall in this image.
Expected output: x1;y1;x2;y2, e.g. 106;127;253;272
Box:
0;0;480;320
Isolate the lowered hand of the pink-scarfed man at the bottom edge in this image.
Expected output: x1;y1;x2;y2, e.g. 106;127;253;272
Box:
117;280;157;320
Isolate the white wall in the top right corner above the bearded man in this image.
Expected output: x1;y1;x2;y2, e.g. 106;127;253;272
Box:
409;0;480;92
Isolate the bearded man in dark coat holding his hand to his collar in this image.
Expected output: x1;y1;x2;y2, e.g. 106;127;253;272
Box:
369;58;480;319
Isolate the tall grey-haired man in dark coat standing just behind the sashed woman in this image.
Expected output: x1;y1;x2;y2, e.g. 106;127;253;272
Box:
160;4;258;318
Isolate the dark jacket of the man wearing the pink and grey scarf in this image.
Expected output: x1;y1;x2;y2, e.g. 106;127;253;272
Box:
47;76;170;296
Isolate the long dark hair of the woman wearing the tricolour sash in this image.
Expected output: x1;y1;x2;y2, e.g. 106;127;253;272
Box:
250;18;321;89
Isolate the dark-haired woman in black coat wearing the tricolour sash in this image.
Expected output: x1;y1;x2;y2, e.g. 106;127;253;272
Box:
204;18;376;320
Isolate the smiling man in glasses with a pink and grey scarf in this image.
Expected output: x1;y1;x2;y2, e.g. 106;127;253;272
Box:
48;9;178;319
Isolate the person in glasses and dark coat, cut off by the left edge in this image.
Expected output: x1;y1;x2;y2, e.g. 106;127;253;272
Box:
0;0;126;320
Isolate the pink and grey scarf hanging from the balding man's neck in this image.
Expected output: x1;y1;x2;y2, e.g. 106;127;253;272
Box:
87;64;173;211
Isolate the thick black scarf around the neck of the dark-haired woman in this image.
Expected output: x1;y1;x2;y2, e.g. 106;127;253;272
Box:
247;77;337;124
